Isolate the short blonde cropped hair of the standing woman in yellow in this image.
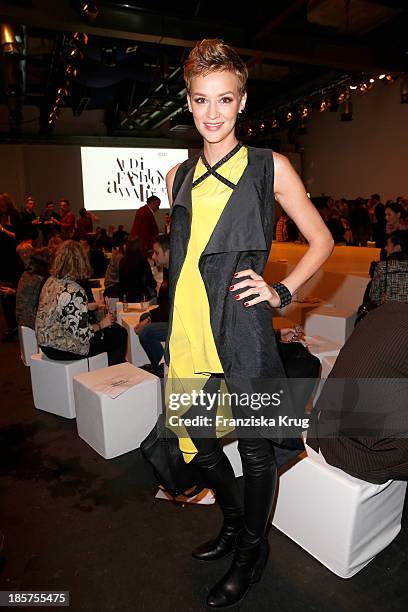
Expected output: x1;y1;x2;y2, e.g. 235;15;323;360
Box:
184;38;248;96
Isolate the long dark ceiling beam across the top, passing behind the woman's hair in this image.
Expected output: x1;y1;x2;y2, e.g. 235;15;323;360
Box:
0;0;403;72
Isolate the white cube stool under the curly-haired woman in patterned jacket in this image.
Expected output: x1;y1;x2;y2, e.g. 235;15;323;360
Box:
30;353;108;419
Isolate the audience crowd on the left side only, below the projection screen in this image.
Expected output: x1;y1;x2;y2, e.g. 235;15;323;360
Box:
0;193;168;366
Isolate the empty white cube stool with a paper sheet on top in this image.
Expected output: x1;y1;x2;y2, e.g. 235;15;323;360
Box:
74;363;161;459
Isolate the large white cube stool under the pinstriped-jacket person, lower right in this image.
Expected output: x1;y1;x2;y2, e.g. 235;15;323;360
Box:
272;447;407;578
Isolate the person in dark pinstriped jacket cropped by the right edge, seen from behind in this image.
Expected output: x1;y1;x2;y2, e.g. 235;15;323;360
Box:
307;301;408;484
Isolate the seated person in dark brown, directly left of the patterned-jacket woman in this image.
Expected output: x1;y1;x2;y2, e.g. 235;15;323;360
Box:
16;247;52;329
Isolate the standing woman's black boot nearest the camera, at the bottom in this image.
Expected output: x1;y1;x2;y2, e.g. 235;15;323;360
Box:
207;537;269;608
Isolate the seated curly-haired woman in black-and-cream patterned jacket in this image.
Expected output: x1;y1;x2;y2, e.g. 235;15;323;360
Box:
35;240;127;365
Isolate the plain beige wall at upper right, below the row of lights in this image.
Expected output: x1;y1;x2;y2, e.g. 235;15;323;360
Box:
299;81;408;201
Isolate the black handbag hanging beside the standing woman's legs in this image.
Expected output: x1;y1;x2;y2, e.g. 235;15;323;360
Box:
140;414;205;497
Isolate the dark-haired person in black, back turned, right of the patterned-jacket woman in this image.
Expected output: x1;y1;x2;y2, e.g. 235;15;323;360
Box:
119;238;156;302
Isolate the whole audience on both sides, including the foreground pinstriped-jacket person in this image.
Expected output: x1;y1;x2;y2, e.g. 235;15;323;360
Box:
0;186;408;492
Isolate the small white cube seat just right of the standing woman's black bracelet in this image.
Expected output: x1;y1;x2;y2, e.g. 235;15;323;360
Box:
304;306;356;346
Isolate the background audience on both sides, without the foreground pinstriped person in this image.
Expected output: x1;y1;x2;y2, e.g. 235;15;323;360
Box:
0;193;408;390
